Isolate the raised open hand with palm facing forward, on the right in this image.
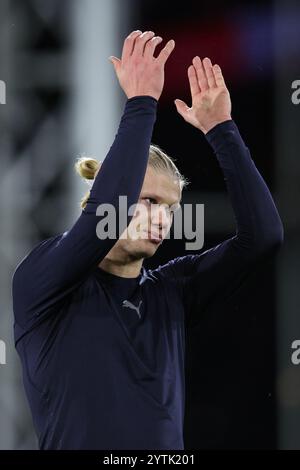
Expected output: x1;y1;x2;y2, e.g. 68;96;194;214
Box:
175;56;231;134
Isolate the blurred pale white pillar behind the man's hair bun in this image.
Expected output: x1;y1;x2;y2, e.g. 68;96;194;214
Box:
69;0;130;225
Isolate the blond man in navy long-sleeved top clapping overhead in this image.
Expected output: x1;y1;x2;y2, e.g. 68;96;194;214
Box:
13;31;283;450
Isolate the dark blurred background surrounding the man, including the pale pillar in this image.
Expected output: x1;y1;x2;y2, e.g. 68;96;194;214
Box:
0;0;300;449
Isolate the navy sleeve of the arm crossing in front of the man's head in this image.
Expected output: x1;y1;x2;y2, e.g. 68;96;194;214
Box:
13;96;157;324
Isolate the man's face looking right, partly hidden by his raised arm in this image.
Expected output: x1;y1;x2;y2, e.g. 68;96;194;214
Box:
112;165;181;259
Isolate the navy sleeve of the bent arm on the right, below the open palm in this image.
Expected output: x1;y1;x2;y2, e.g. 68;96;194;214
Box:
152;120;283;321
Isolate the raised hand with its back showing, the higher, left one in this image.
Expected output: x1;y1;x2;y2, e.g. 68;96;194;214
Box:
109;30;175;100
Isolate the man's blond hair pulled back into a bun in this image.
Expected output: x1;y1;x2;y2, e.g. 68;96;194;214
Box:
75;144;189;209
